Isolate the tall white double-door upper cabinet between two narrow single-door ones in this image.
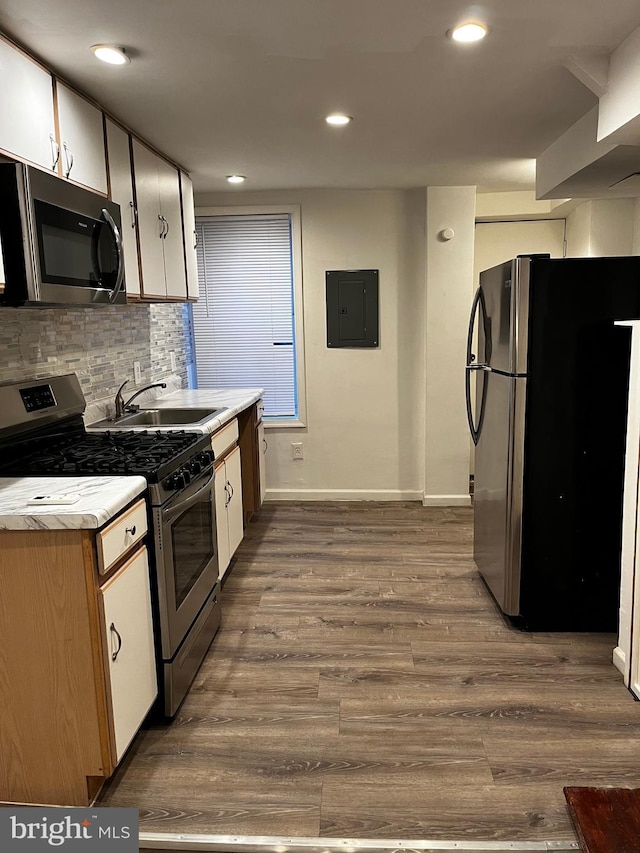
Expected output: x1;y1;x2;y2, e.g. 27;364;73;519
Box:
133;138;187;299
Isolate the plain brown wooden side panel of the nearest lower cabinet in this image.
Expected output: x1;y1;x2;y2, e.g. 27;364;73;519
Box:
0;531;105;805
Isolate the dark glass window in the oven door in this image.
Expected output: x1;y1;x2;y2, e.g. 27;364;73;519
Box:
171;497;215;610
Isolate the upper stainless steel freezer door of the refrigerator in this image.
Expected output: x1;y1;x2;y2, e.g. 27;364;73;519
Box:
478;258;531;375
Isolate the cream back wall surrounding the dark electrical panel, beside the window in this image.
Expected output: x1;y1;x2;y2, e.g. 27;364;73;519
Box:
196;190;425;500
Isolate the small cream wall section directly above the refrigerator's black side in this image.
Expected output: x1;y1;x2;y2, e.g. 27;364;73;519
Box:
567;198;640;258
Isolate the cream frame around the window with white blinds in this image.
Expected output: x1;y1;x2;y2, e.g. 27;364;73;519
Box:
195;204;307;429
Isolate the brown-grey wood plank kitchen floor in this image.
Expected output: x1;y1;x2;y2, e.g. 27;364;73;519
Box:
100;503;640;841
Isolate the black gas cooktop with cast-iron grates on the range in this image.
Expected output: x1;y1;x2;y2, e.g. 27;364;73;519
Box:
0;430;207;483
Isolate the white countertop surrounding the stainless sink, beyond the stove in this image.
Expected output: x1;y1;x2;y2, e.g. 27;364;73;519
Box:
86;388;264;435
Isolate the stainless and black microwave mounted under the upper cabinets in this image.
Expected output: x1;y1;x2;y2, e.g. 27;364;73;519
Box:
0;163;126;307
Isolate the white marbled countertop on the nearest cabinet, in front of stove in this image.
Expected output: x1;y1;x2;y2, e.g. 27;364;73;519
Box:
0;476;147;530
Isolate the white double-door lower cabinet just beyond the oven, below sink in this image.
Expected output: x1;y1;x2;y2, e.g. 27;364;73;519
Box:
215;446;244;578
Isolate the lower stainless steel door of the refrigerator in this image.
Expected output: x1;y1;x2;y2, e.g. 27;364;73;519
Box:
474;372;527;616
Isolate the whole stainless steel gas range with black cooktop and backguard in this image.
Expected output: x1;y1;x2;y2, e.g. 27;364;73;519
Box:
0;374;221;717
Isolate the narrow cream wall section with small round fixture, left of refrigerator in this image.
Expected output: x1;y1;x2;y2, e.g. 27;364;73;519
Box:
424;187;476;505
